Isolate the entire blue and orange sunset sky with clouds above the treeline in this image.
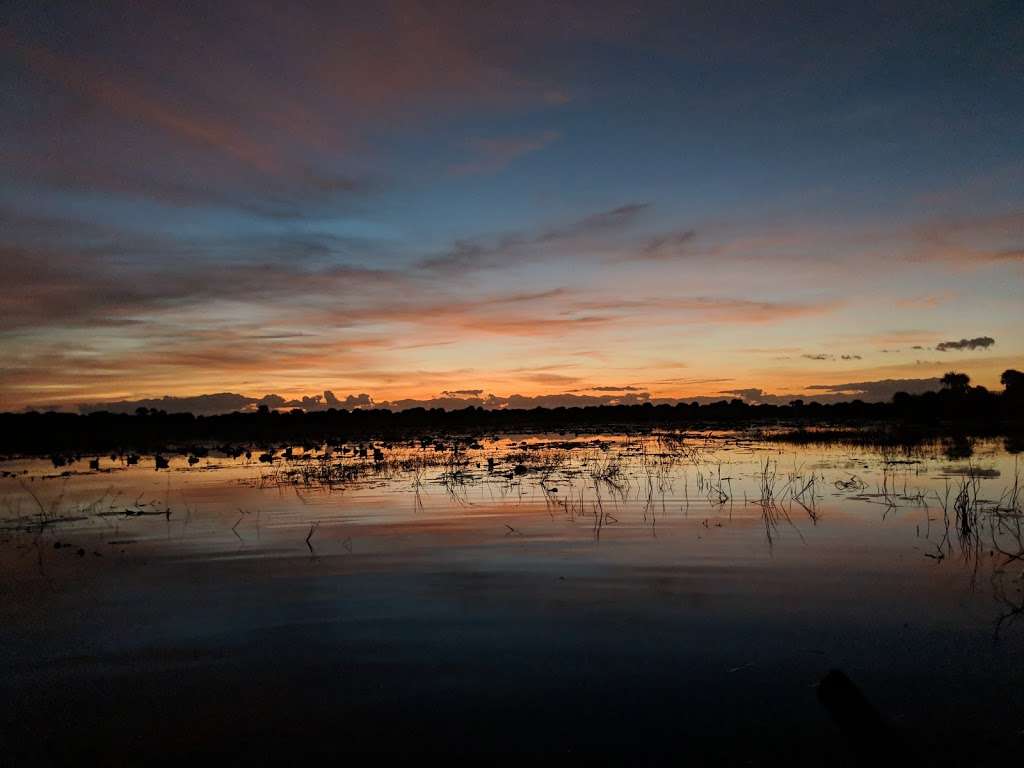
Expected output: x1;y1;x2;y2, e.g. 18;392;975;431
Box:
0;0;1024;410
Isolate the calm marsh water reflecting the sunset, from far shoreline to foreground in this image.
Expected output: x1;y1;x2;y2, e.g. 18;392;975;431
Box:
0;433;1024;765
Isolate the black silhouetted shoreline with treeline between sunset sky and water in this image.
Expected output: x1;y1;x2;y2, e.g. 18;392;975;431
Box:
0;388;1024;456
